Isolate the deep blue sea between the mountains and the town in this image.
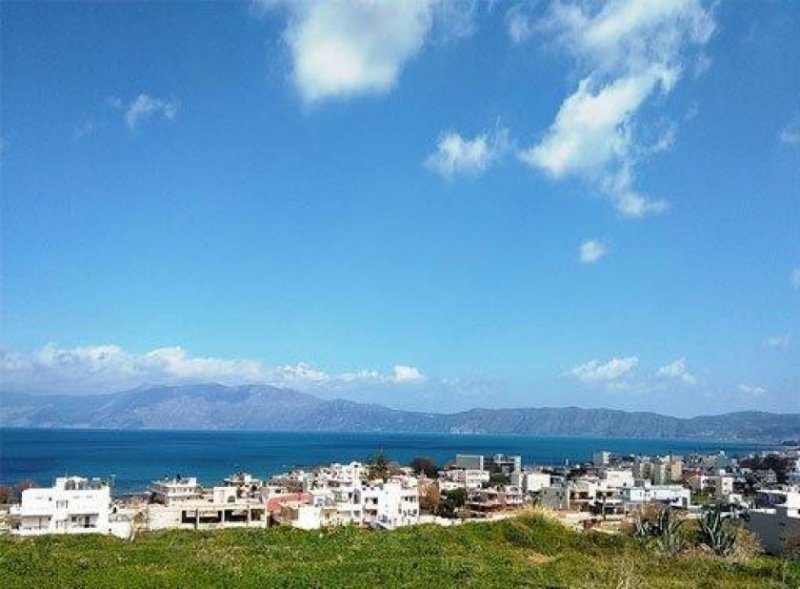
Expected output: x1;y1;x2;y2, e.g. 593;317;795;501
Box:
0;428;764;495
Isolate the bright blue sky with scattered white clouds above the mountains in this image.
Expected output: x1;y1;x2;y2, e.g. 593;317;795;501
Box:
0;0;800;416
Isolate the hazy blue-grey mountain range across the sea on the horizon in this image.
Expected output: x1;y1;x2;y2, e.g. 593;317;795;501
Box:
0;384;800;441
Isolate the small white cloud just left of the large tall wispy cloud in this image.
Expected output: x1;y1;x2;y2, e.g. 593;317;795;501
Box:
425;127;509;179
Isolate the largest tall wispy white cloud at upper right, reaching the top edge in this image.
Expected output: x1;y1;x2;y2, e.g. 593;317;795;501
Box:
512;0;714;217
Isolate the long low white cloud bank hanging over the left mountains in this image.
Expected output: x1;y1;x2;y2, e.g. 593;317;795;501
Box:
0;344;426;393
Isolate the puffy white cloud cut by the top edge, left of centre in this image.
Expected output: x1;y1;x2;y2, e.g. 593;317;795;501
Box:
259;0;474;104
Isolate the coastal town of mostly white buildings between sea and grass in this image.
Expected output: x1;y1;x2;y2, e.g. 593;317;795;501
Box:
2;446;800;554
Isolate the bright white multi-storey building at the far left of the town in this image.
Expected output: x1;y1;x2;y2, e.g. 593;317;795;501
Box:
14;477;130;537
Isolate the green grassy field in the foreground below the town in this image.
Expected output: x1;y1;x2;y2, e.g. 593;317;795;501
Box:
0;515;800;589
